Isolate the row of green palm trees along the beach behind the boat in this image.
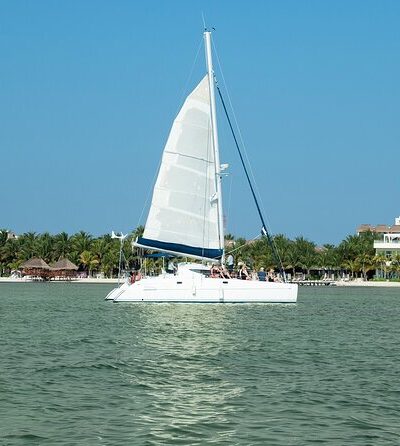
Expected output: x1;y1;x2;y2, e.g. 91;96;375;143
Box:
0;226;400;279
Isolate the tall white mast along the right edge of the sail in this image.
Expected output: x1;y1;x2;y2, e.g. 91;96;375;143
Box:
204;31;225;264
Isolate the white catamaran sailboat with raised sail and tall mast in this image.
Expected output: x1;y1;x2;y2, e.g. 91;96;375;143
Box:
106;31;298;303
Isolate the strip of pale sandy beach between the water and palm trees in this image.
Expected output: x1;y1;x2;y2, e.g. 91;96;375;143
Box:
0;277;400;288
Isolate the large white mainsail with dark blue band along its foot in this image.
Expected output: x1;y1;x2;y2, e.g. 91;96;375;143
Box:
135;75;223;259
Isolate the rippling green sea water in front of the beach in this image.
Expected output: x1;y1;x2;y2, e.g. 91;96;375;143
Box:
0;283;400;446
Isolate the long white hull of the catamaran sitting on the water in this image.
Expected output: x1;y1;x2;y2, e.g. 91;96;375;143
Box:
106;274;298;303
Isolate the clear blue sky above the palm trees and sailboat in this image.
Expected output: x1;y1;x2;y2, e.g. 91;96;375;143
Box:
0;0;400;244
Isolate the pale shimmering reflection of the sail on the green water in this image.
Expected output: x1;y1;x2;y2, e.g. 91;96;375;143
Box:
117;305;255;444
